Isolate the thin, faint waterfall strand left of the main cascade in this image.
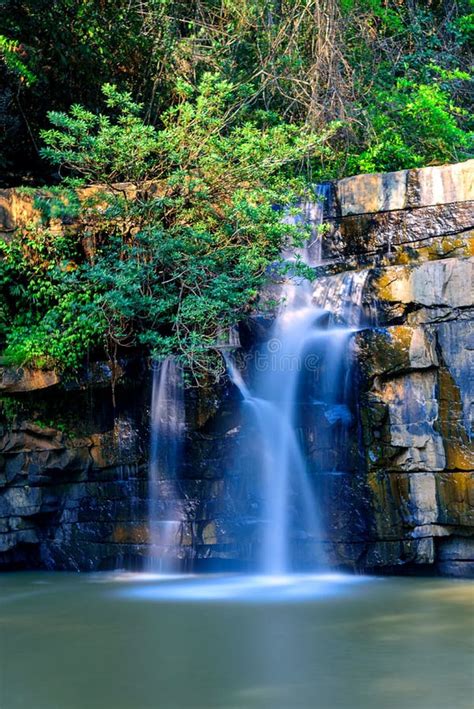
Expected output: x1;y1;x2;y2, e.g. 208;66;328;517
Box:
148;357;185;571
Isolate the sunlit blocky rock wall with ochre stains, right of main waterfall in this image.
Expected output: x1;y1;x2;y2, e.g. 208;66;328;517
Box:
351;163;474;575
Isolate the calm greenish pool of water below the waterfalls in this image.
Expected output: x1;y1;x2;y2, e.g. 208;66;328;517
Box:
0;572;474;709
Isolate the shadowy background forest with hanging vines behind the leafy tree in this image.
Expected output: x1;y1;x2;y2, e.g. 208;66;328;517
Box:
0;0;473;177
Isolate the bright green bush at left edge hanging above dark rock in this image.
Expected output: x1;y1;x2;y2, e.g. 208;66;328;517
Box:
0;221;103;368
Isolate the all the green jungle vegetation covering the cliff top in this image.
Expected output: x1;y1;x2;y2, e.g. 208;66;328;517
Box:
0;0;474;375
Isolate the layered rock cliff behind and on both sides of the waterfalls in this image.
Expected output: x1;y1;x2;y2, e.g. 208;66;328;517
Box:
0;161;474;575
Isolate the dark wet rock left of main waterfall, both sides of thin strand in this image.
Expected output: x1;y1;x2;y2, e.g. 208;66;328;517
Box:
0;366;244;570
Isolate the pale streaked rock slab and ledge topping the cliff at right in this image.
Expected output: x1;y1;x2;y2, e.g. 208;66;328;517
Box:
316;160;474;268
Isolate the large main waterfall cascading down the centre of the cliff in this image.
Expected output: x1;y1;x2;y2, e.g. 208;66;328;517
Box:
229;186;366;575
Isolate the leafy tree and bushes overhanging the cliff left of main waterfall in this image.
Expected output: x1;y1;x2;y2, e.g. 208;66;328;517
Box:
0;75;330;374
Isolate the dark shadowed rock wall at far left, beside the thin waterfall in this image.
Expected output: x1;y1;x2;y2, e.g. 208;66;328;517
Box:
0;388;145;569
